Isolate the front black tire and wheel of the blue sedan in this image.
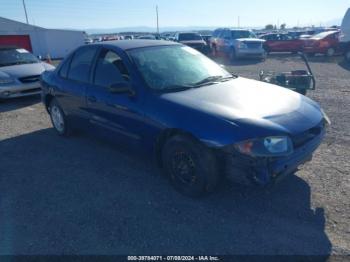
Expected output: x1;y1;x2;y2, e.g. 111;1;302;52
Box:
162;135;219;197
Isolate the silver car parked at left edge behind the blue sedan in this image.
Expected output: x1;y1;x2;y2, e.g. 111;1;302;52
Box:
0;46;54;99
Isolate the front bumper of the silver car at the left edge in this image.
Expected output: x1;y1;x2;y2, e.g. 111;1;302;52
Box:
0;81;41;99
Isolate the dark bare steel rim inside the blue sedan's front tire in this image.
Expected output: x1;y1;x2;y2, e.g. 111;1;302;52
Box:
172;152;196;185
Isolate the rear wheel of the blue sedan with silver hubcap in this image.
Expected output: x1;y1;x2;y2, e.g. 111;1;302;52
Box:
49;98;71;137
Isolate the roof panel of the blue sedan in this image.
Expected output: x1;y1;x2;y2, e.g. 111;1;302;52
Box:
92;39;179;51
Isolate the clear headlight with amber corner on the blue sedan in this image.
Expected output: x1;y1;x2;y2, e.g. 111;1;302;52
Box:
234;136;293;157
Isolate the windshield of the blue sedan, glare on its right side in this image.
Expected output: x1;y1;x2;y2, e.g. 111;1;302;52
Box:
129;45;232;92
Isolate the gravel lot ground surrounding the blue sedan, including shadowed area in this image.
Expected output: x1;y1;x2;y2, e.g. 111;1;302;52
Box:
0;55;350;255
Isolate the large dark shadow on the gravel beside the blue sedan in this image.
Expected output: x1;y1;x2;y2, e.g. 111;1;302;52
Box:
0;129;332;256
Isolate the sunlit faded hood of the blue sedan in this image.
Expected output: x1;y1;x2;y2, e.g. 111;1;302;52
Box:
162;77;323;134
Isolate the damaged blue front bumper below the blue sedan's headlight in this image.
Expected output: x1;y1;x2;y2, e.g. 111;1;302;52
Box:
225;129;325;186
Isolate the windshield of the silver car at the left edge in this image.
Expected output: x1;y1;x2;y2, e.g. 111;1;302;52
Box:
0;48;39;66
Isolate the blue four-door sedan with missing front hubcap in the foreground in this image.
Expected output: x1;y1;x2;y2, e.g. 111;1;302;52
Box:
42;40;328;196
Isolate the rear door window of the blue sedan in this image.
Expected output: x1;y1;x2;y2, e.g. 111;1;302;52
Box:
68;47;97;83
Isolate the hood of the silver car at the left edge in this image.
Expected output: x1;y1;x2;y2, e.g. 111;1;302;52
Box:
0;62;55;78
